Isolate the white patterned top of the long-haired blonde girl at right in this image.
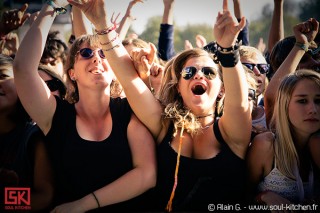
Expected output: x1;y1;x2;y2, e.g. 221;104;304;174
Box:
258;158;313;203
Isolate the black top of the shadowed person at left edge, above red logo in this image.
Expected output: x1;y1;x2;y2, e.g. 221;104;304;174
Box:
0;122;42;209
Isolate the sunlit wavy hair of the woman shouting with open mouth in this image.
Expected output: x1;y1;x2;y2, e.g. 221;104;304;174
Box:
159;48;223;134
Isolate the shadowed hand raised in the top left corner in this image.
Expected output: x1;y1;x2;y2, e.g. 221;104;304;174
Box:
0;4;30;35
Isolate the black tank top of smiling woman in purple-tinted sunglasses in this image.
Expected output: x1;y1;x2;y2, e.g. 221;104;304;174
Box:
46;98;145;212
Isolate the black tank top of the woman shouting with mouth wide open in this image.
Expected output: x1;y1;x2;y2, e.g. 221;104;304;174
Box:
149;120;245;212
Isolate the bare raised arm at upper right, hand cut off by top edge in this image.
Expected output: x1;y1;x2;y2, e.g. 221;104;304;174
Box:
268;0;284;53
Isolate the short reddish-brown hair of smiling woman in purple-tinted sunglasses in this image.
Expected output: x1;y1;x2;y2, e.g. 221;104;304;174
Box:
65;35;122;103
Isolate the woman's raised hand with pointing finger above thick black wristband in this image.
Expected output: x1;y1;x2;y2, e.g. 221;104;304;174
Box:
213;0;246;48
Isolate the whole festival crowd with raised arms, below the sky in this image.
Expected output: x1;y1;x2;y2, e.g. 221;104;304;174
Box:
0;0;320;213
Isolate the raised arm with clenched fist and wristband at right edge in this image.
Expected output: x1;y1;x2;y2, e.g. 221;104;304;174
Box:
264;18;319;125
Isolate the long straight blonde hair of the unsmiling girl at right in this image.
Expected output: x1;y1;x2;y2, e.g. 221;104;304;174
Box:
270;69;320;201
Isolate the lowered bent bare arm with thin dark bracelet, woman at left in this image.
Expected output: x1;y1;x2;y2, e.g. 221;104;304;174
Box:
51;115;156;212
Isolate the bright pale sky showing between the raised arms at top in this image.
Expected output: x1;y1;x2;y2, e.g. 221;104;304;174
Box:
107;0;301;33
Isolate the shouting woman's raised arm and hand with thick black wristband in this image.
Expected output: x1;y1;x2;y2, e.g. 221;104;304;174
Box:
214;0;251;150
